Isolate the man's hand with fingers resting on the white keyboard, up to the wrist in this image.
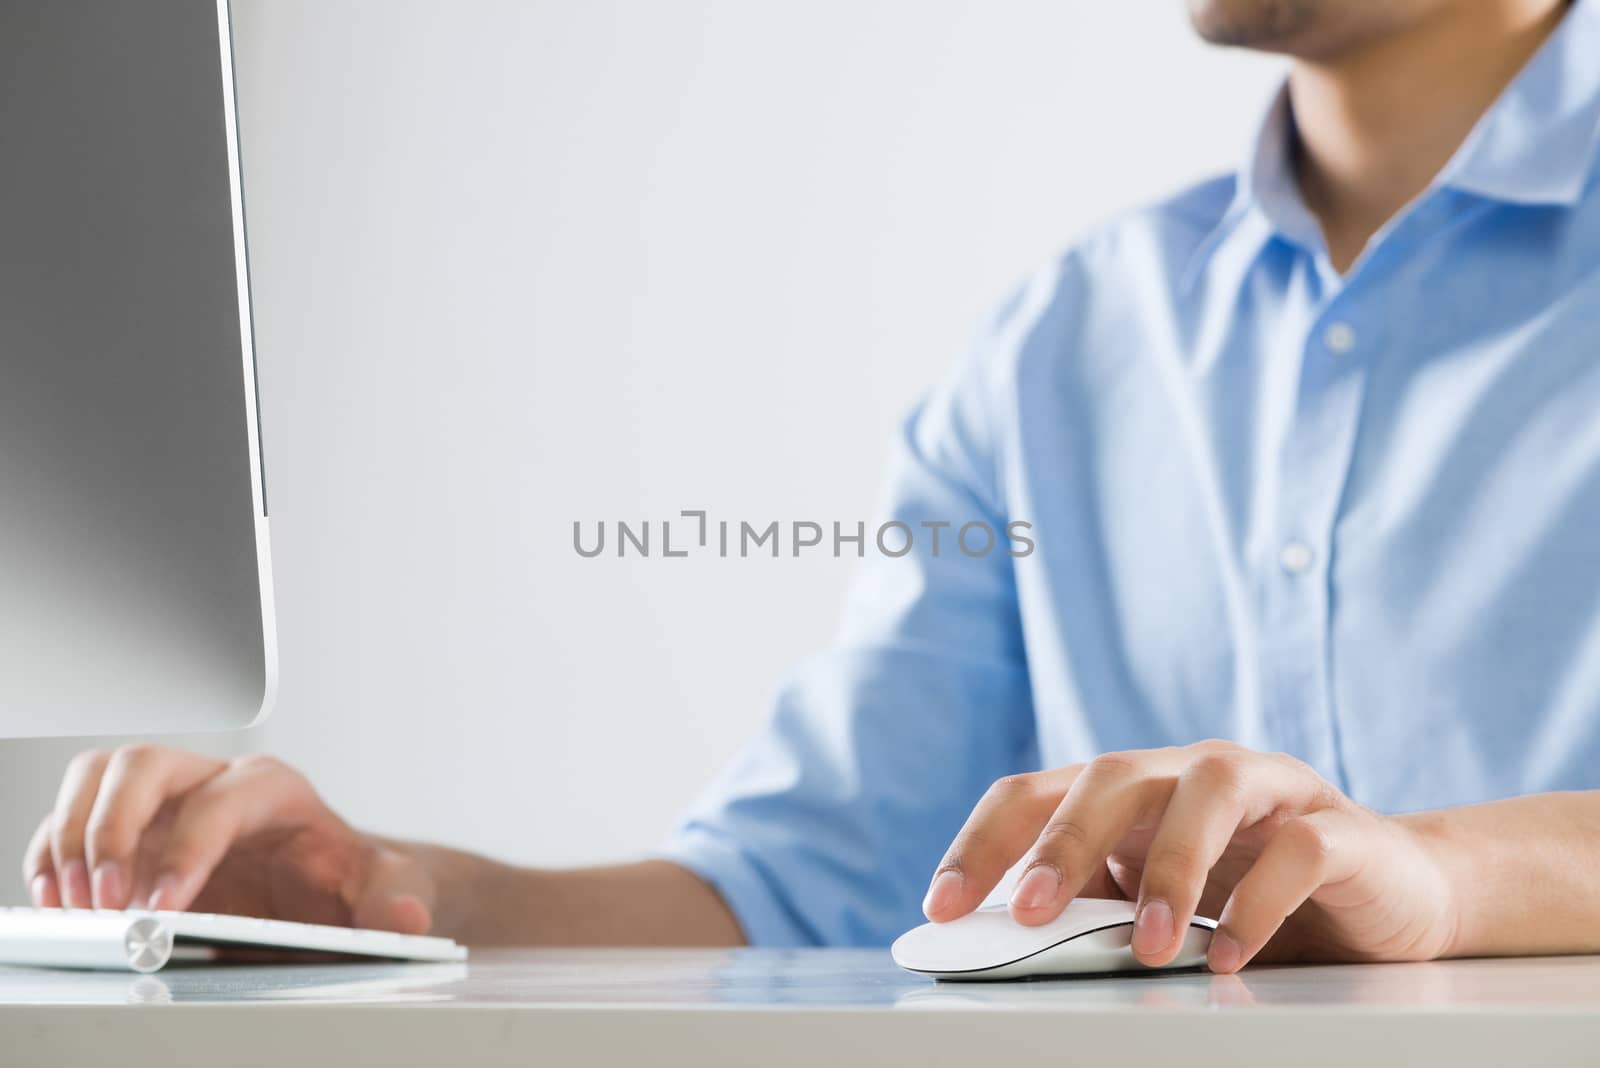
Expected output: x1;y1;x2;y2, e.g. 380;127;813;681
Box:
22;745;435;934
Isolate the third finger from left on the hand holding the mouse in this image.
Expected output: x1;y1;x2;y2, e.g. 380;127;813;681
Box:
1133;750;1322;967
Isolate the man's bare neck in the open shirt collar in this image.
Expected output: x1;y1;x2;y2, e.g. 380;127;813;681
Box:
1290;0;1566;272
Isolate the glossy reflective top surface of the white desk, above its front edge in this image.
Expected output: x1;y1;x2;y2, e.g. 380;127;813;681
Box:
0;950;1600;1010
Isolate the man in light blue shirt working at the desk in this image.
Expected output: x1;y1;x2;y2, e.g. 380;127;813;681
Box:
24;0;1600;972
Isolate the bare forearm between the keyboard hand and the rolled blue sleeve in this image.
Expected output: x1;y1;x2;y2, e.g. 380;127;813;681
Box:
395;843;744;946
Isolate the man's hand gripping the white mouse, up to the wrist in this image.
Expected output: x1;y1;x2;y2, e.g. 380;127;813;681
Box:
923;742;1456;972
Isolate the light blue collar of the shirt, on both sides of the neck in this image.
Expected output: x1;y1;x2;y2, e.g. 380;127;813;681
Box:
1182;0;1600;289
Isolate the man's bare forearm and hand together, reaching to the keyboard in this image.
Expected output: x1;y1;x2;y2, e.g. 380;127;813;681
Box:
22;745;744;945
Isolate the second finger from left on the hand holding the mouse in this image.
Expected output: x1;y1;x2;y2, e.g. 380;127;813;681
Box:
1011;751;1173;924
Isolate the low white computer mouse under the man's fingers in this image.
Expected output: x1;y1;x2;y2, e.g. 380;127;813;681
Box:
890;897;1216;978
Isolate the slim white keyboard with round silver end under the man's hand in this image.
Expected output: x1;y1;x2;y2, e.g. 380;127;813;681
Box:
0;908;467;972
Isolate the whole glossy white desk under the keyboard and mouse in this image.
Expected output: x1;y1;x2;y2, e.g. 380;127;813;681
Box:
0;950;1600;1068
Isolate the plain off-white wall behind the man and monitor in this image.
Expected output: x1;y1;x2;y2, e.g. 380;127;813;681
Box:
0;0;1278;900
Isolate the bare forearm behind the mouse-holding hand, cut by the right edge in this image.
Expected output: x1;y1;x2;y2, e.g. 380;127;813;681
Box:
1400;791;1600;956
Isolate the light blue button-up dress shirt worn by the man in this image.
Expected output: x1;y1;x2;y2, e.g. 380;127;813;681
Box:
662;0;1600;945
